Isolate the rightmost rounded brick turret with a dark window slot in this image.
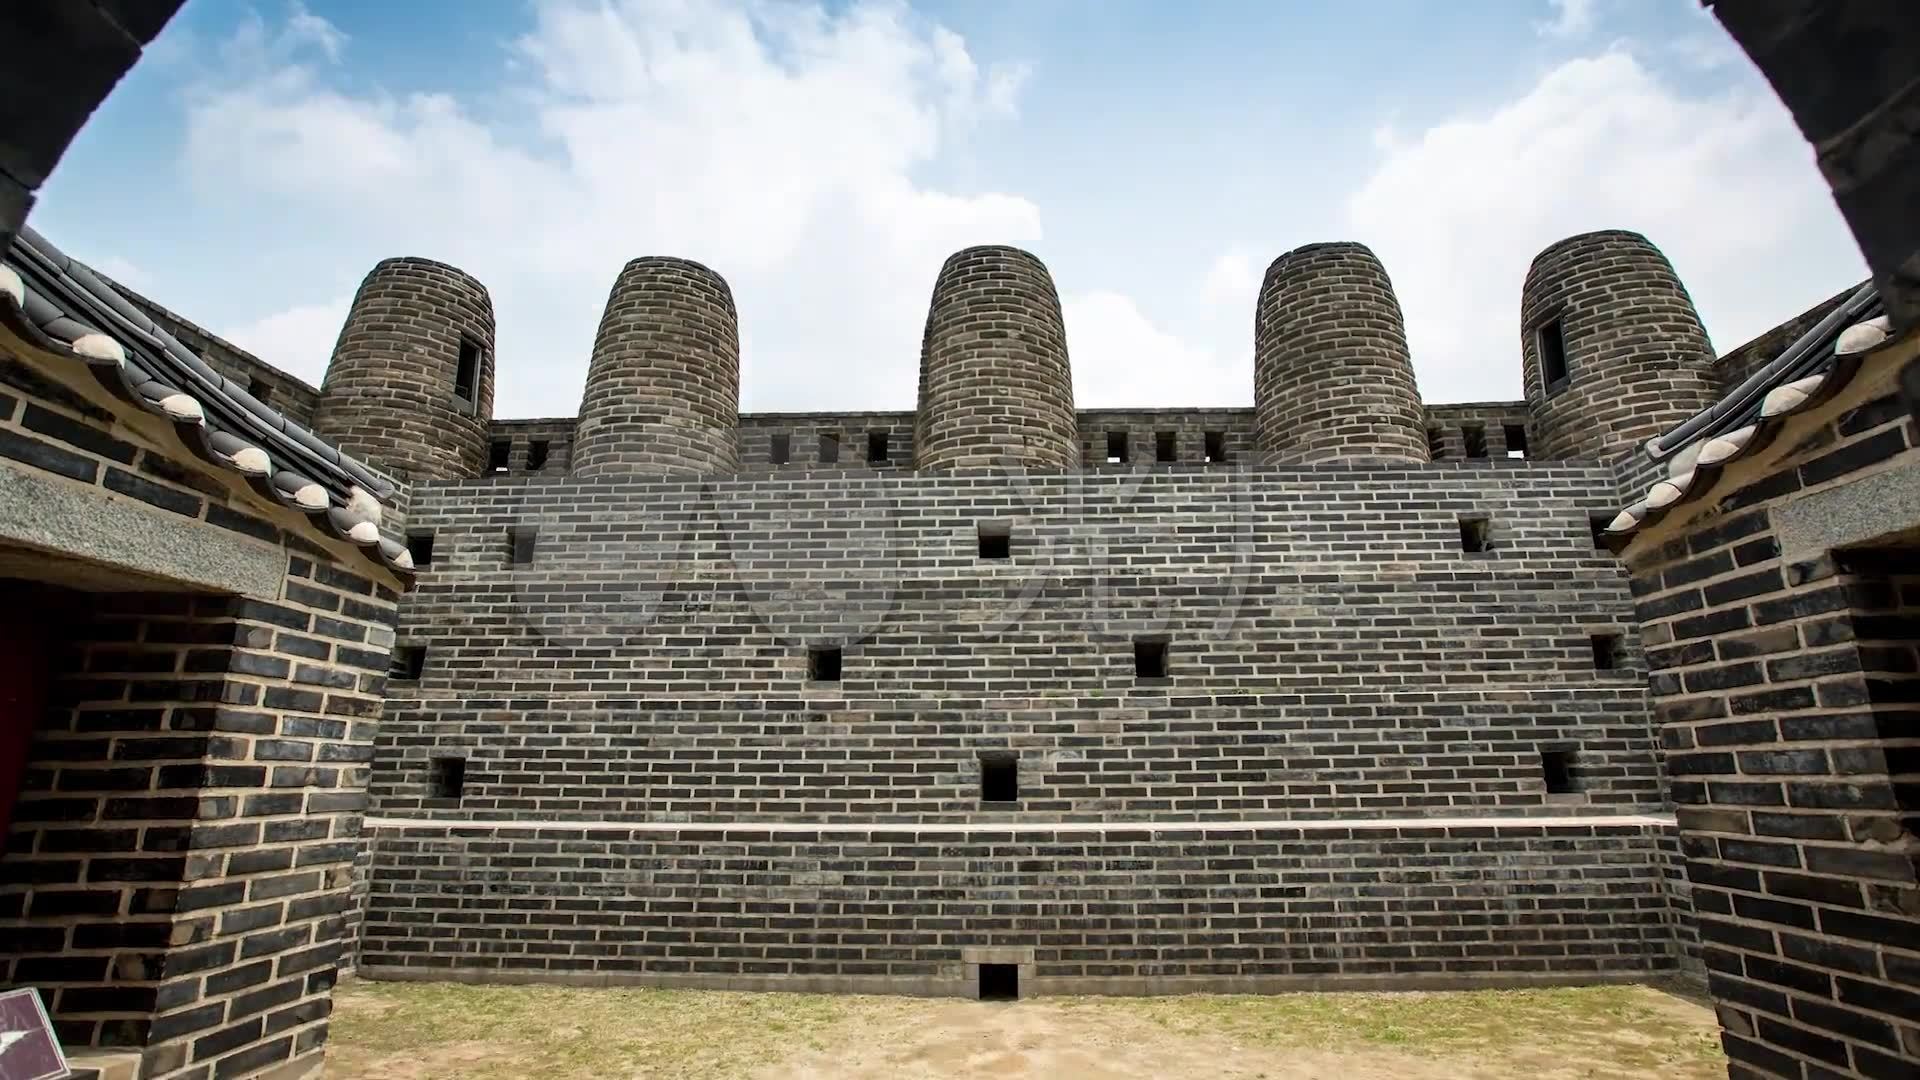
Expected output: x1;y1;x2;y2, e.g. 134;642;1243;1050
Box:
1521;231;1718;457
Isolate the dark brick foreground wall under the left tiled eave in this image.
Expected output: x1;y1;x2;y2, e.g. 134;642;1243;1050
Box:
0;357;397;1080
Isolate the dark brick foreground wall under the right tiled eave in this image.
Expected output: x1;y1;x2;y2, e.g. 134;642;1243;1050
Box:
1626;374;1920;1080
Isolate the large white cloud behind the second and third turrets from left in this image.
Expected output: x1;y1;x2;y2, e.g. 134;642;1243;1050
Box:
186;0;1041;415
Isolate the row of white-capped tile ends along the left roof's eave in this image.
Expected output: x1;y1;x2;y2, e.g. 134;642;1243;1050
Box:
0;290;415;586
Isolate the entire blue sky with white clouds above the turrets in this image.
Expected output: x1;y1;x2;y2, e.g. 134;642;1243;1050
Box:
33;0;1866;417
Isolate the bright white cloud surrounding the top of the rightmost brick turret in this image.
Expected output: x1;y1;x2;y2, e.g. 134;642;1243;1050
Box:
1346;50;1866;402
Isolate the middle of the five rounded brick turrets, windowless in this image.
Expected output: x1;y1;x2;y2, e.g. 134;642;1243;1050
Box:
914;246;1081;473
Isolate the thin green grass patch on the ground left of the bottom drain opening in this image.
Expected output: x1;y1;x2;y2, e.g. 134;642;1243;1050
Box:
328;980;858;1080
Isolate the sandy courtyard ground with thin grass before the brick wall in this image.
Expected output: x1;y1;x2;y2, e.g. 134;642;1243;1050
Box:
326;980;1726;1080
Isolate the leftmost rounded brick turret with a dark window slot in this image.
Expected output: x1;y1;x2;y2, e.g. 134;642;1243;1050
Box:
313;259;493;480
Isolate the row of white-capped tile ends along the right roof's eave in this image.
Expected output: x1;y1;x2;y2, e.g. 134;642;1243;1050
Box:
1601;326;1891;553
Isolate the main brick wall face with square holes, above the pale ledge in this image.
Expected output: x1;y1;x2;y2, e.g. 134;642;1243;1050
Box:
374;461;1661;821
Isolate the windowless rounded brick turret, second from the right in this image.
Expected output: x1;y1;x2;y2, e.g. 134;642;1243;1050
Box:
1254;242;1427;465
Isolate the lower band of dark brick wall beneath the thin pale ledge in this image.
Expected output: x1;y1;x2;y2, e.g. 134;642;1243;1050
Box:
361;822;1672;994
